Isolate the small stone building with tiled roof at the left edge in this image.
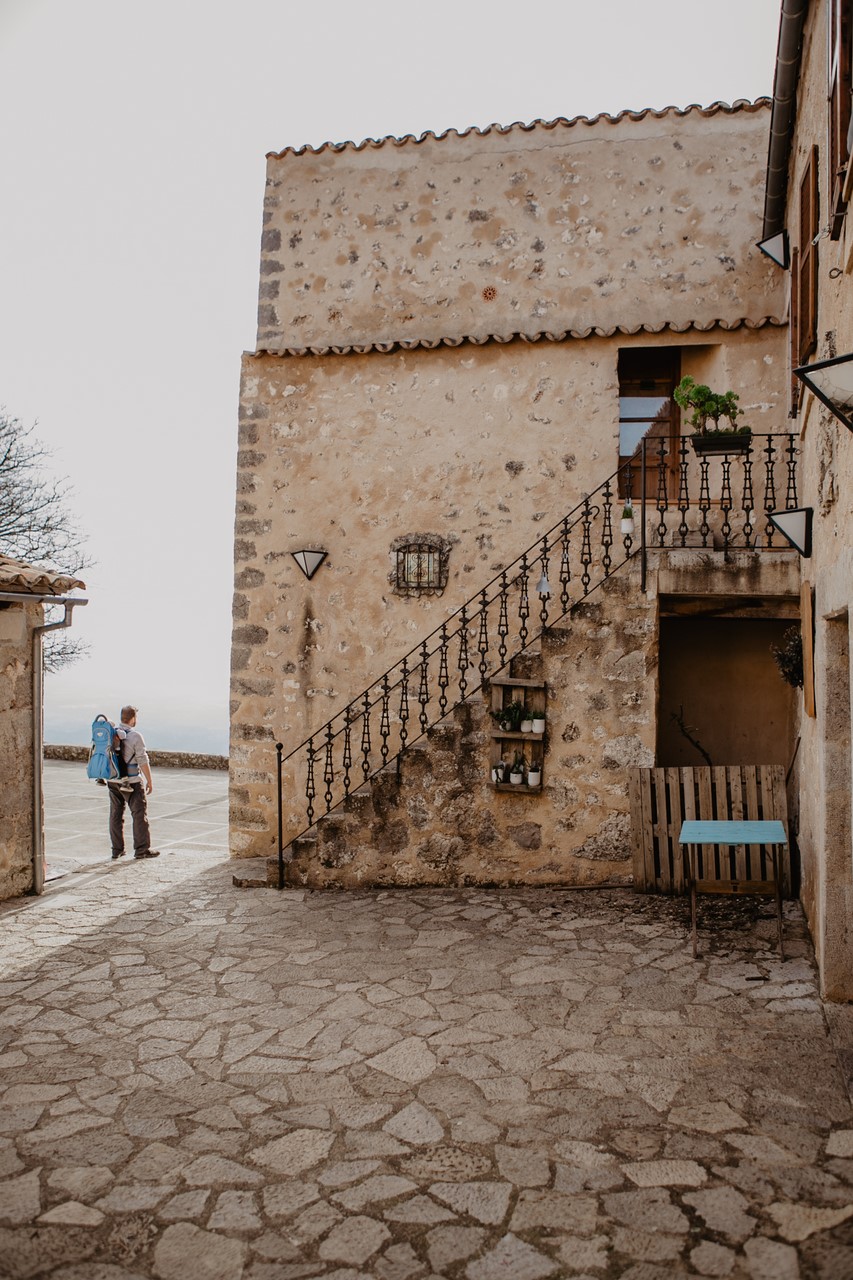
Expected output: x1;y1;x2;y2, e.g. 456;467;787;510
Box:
0;556;86;901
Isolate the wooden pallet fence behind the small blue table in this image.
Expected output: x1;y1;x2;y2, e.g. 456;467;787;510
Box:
630;764;792;897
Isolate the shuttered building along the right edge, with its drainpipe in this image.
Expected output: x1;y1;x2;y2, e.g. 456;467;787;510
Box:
765;0;853;1000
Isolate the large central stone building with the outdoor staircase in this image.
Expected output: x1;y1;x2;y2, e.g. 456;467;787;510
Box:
231;100;799;884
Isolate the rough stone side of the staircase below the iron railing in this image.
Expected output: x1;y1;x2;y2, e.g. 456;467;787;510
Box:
251;564;653;888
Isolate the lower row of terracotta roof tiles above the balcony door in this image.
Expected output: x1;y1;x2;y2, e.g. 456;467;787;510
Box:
248;316;788;357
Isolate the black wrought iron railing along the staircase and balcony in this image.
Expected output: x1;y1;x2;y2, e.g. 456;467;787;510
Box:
275;434;798;888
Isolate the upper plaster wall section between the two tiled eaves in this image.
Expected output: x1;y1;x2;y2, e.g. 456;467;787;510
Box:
257;100;784;351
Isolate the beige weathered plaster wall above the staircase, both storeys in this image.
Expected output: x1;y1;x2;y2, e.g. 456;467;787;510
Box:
231;104;785;870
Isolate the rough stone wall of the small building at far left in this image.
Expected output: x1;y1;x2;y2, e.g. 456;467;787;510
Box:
0;604;41;901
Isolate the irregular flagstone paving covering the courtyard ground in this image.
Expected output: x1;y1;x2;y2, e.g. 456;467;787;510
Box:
0;771;853;1280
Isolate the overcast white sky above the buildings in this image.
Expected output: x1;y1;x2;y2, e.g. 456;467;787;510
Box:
0;0;780;751
